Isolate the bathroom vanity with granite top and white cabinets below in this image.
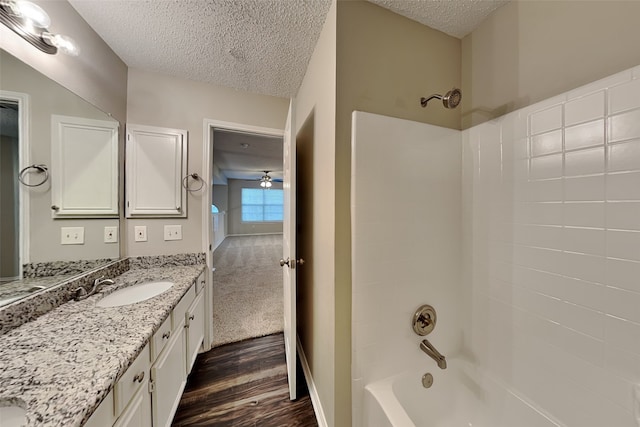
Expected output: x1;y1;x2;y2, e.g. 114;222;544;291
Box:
0;264;211;427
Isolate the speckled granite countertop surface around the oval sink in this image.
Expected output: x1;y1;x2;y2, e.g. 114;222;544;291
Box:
0;265;205;427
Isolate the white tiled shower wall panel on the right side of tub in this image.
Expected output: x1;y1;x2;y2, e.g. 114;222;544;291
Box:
463;67;640;427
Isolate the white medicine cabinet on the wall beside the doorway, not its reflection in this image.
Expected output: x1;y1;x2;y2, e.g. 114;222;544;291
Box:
126;125;187;218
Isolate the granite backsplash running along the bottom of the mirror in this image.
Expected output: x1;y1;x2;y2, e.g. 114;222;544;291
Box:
0;259;129;335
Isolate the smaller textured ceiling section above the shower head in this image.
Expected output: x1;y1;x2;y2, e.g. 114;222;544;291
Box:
369;0;509;39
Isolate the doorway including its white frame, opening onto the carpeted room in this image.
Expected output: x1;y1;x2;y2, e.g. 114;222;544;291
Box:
203;120;283;345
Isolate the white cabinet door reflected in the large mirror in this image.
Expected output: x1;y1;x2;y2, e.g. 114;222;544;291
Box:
51;115;118;218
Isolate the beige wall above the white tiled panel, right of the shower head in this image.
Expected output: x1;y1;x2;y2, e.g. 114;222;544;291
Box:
462;1;640;129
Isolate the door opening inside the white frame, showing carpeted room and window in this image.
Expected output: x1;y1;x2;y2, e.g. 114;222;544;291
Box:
211;128;284;347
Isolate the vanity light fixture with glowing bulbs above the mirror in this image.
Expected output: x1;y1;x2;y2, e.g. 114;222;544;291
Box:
0;0;80;56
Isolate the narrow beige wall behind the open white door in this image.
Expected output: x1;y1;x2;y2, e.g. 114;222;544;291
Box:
295;2;338;426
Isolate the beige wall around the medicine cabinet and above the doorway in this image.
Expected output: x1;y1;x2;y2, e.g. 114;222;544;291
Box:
126;68;289;256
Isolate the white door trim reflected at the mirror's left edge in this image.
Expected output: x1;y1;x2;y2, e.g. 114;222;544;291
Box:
0;90;30;277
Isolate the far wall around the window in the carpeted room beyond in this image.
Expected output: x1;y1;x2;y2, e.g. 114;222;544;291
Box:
227;179;282;235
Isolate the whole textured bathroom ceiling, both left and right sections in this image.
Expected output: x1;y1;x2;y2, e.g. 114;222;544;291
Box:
69;0;506;98
